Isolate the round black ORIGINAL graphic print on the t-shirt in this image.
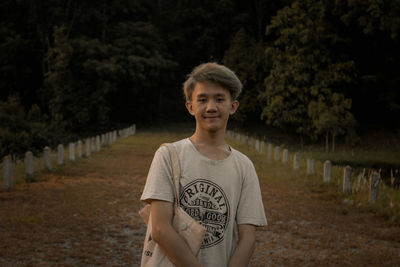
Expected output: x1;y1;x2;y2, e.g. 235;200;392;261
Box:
179;179;230;248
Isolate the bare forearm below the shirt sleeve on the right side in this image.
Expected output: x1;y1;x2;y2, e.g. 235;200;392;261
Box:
229;224;256;267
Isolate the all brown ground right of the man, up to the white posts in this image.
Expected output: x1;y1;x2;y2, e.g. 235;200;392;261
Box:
231;141;400;266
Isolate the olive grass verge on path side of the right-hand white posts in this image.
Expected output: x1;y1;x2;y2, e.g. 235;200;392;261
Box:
229;136;400;225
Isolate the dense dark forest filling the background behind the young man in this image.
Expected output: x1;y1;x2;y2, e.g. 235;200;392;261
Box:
0;0;400;156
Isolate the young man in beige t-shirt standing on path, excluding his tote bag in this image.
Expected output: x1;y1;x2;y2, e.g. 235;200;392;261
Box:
141;63;267;267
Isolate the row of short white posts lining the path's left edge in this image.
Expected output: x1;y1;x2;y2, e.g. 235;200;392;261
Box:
2;124;136;191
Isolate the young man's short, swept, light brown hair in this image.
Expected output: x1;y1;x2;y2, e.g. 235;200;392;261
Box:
183;62;243;101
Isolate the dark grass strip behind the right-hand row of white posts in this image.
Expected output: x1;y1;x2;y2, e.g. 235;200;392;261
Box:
228;126;400;170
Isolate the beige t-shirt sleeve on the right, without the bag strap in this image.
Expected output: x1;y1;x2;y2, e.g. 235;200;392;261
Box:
236;162;267;226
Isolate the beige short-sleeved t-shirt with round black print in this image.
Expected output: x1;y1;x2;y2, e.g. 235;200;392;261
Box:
141;138;267;266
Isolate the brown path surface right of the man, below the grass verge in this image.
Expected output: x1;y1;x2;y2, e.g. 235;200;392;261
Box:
252;183;400;266
